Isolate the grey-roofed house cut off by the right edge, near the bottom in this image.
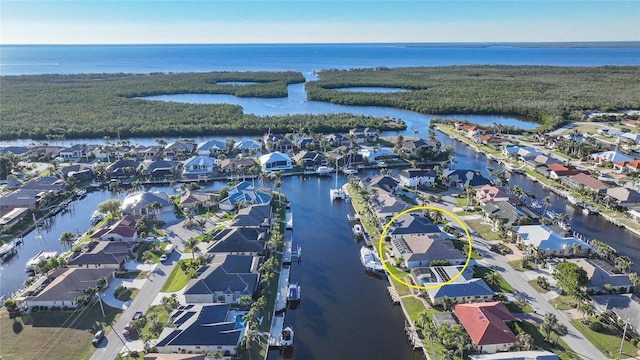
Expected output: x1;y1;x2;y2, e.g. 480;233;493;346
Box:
591;294;640;337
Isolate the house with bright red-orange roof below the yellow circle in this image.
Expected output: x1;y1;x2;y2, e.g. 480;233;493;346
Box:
453;301;516;354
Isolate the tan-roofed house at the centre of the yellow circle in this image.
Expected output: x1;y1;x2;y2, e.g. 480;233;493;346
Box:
391;234;466;269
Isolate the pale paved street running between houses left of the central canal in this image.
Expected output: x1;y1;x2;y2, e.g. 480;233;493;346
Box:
90;221;204;360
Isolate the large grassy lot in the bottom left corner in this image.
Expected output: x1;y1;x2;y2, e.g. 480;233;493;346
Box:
0;303;122;360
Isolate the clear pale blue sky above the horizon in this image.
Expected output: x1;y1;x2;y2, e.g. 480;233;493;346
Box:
0;0;640;44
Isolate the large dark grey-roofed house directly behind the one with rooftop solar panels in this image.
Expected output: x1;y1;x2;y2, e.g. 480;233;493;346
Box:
184;254;260;304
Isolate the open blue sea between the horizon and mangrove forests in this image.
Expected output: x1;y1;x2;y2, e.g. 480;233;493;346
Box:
0;44;640;75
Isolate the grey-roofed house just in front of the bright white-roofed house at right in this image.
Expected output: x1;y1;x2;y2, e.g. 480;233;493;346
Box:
564;259;632;294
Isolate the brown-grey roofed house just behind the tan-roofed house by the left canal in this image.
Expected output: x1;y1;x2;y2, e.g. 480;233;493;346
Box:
67;241;130;269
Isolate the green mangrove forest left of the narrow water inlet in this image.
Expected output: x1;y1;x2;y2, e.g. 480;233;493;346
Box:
0;72;404;140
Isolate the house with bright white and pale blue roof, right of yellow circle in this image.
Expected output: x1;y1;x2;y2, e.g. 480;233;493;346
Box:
513;225;592;257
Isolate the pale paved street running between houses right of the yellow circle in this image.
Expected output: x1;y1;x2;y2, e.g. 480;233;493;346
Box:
442;196;607;360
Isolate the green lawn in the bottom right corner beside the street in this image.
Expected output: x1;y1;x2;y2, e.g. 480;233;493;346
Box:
571;318;638;359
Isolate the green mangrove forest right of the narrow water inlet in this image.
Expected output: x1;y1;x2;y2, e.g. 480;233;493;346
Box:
305;66;640;128
